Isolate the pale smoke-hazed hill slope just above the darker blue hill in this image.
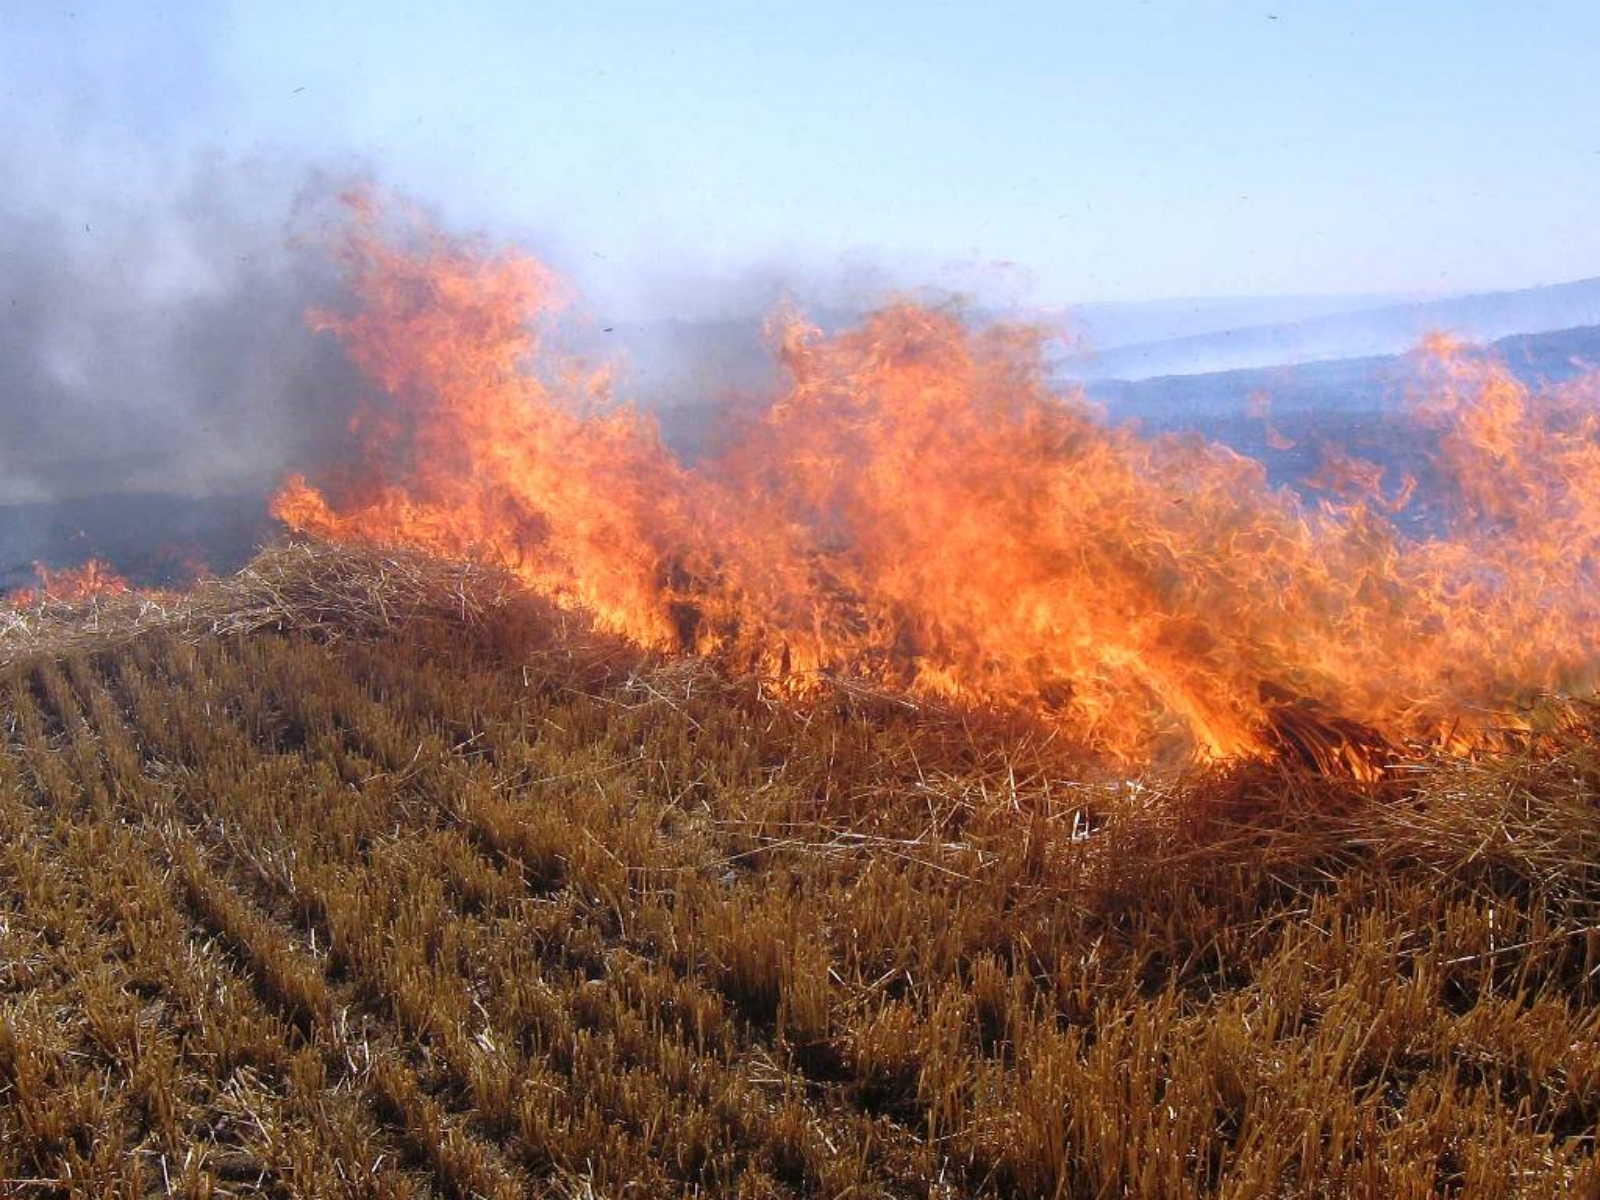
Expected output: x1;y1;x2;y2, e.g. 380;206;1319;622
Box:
1056;278;1600;379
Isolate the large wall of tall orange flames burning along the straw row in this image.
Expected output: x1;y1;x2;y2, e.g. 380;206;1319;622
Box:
274;202;1600;760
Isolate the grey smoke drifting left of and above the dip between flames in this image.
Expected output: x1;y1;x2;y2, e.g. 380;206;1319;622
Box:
0;6;1036;576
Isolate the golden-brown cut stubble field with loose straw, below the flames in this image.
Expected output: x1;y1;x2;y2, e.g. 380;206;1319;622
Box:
0;546;1600;1197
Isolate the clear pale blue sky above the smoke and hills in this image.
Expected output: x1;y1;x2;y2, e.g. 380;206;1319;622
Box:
9;0;1600;304
